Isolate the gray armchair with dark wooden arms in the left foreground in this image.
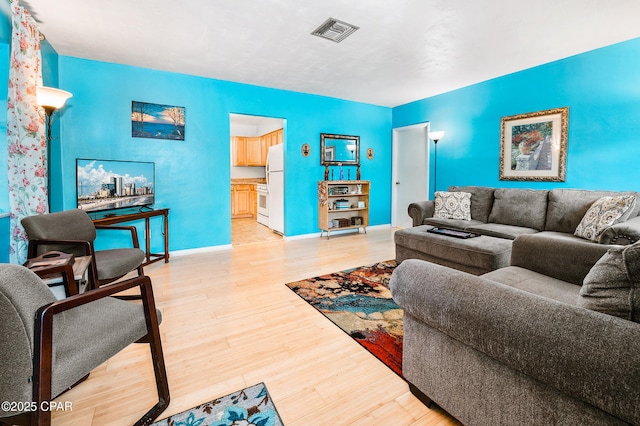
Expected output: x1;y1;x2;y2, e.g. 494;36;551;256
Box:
0;264;169;425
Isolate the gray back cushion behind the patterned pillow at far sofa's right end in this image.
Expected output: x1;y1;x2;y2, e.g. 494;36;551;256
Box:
545;189;640;234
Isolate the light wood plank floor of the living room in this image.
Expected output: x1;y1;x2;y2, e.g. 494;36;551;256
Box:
53;229;458;426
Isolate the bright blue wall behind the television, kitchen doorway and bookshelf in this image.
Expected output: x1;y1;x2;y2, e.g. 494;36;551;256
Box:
53;56;392;251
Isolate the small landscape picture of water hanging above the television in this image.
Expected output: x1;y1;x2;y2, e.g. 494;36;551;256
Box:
131;101;185;141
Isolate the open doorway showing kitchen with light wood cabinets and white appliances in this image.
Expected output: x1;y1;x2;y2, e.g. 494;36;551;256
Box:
229;114;284;246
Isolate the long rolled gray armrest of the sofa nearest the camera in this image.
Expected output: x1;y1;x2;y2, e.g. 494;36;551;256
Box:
391;259;640;424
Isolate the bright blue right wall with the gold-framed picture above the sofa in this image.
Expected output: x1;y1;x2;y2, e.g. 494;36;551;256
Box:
393;39;640;196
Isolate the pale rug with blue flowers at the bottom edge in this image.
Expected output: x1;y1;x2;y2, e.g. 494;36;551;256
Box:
153;383;283;426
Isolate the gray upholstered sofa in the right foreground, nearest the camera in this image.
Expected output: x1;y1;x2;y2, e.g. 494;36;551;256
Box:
391;243;640;426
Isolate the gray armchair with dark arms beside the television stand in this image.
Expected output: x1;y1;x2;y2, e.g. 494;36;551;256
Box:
22;209;145;288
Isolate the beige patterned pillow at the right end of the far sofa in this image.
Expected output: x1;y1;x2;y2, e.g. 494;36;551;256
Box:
573;195;636;242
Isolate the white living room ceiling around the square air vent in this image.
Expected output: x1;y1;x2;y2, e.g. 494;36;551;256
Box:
21;0;640;106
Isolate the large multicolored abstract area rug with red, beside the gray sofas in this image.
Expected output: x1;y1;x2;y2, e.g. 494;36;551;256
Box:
287;260;403;377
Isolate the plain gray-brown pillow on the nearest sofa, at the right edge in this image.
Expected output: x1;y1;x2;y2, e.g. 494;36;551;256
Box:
578;243;640;322
